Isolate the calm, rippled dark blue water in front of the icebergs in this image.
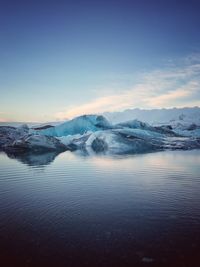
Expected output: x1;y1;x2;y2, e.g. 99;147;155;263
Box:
0;150;200;267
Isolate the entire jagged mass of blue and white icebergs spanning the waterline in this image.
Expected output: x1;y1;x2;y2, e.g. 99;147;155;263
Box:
0;115;200;154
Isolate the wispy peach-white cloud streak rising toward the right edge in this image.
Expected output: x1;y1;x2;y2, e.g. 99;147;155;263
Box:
56;54;200;119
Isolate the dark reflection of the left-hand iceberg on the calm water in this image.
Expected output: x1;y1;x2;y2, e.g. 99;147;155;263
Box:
6;152;60;166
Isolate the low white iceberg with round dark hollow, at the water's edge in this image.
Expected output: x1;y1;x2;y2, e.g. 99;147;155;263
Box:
60;129;163;154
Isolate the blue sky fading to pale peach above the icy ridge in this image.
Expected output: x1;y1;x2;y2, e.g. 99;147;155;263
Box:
0;0;200;122
